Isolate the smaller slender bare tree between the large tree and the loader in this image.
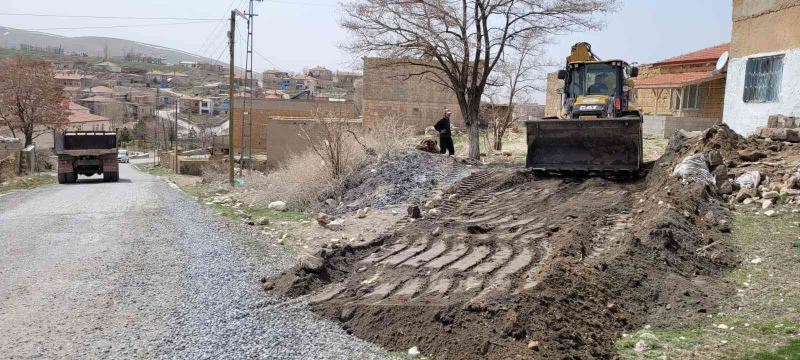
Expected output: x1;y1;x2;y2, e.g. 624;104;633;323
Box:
484;38;552;151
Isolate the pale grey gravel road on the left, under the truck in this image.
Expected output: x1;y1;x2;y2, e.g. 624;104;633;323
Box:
0;164;389;359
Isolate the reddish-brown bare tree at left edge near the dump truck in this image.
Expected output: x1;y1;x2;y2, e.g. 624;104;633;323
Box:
0;56;68;146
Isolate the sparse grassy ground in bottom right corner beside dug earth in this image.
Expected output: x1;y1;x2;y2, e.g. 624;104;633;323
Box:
615;213;800;360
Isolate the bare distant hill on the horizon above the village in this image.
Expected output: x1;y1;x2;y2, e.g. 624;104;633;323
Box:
0;26;226;64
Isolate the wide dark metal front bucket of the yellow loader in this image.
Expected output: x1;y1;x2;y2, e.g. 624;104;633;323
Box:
525;117;643;173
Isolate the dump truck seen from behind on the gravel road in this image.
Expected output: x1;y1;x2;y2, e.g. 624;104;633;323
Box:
55;131;119;184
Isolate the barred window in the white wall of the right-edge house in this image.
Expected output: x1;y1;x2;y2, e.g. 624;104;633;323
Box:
744;55;783;103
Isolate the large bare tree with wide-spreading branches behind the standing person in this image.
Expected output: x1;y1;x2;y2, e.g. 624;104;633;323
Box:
341;0;616;159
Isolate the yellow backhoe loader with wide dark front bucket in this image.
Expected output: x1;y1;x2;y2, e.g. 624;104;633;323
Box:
526;42;643;176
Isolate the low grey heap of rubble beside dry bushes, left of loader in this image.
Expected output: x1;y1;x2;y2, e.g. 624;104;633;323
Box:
325;149;470;213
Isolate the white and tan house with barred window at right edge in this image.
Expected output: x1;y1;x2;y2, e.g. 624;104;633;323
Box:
724;0;800;134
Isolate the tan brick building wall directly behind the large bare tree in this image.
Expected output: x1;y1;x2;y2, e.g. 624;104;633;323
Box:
363;58;464;131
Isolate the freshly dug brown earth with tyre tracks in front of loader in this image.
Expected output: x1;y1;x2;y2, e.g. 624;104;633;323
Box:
264;127;742;359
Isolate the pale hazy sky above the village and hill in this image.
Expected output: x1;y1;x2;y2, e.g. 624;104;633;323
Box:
0;0;732;99
